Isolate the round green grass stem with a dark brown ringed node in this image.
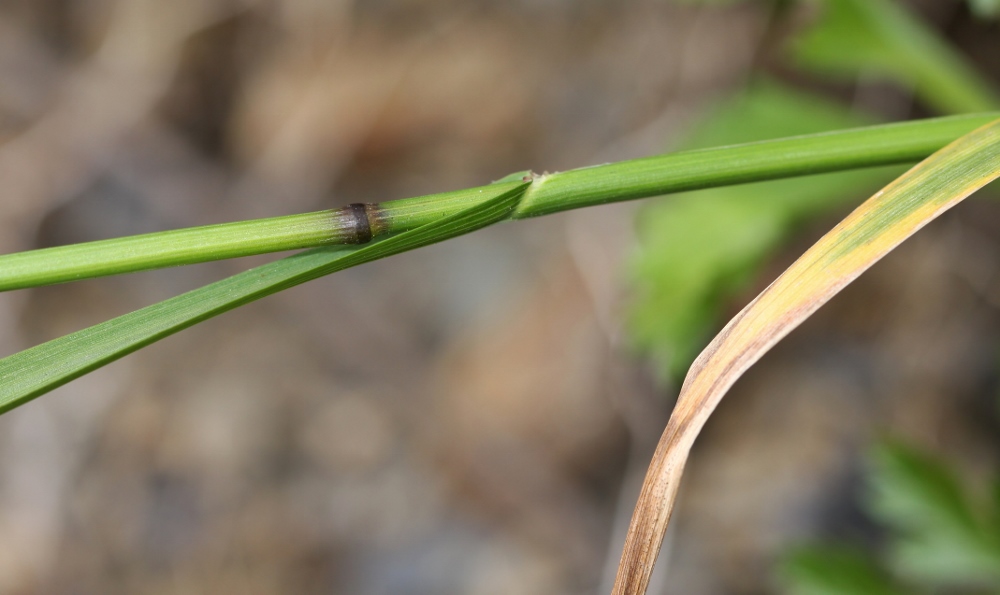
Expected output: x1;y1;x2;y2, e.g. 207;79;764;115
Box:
0;113;1000;291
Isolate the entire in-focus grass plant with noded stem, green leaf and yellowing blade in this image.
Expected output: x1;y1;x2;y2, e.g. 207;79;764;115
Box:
0;102;1000;595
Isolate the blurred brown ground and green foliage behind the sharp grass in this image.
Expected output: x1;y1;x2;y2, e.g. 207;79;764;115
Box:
0;0;1000;595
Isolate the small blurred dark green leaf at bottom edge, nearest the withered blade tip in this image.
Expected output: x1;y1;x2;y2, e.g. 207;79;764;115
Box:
780;545;904;595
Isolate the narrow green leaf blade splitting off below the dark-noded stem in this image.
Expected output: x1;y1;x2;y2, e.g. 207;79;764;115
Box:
0;182;528;413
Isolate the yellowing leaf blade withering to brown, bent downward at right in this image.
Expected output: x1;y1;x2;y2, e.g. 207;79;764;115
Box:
612;120;1000;595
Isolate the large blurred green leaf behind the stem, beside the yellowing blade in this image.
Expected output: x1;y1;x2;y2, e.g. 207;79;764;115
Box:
629;81;897;375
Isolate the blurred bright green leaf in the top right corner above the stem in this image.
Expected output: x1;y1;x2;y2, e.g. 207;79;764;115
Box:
791;0;1000;113
